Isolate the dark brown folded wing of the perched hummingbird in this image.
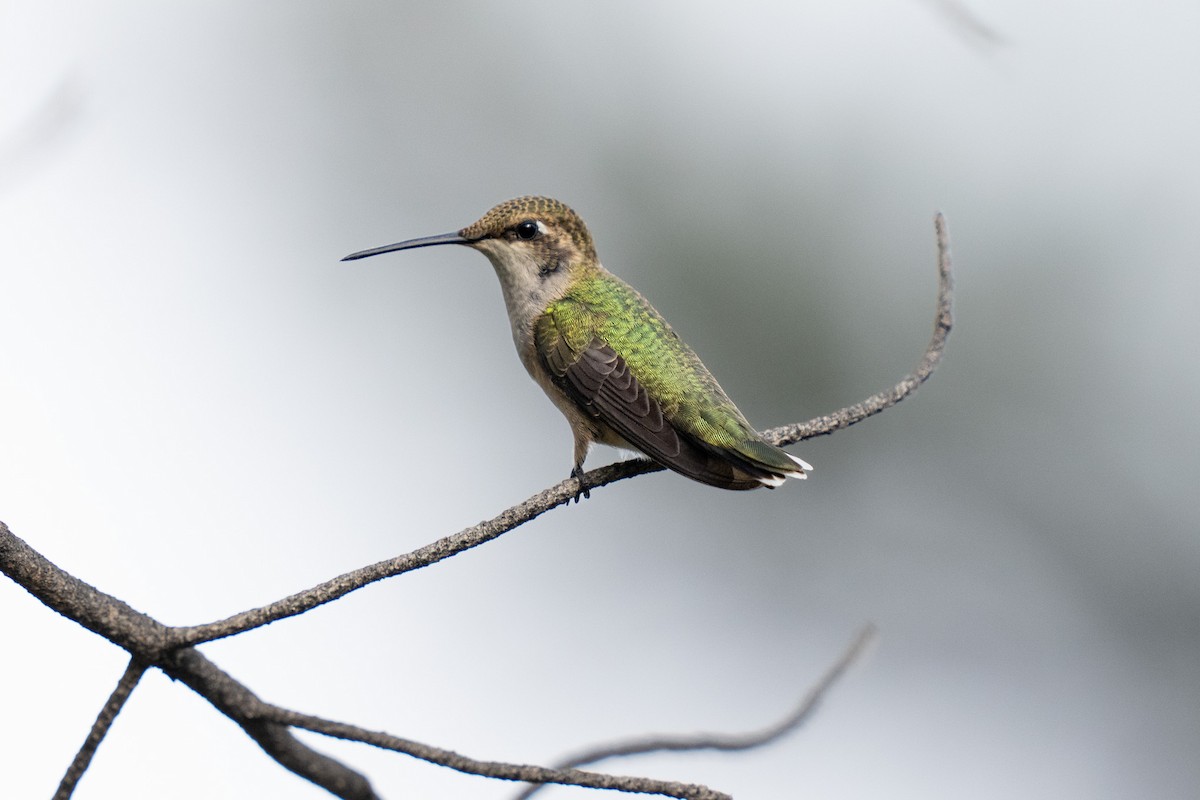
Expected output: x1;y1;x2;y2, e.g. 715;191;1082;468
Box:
535;313;763;489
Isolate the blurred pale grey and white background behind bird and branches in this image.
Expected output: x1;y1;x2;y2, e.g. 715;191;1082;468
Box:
0;0;1200;800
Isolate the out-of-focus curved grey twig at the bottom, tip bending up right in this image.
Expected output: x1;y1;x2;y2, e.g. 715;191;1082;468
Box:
512;625;875;800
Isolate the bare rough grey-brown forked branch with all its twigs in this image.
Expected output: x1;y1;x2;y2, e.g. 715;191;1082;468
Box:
0;215;953;800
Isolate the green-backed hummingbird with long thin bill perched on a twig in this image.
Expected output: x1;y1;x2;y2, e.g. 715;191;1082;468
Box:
342;197;812;503
